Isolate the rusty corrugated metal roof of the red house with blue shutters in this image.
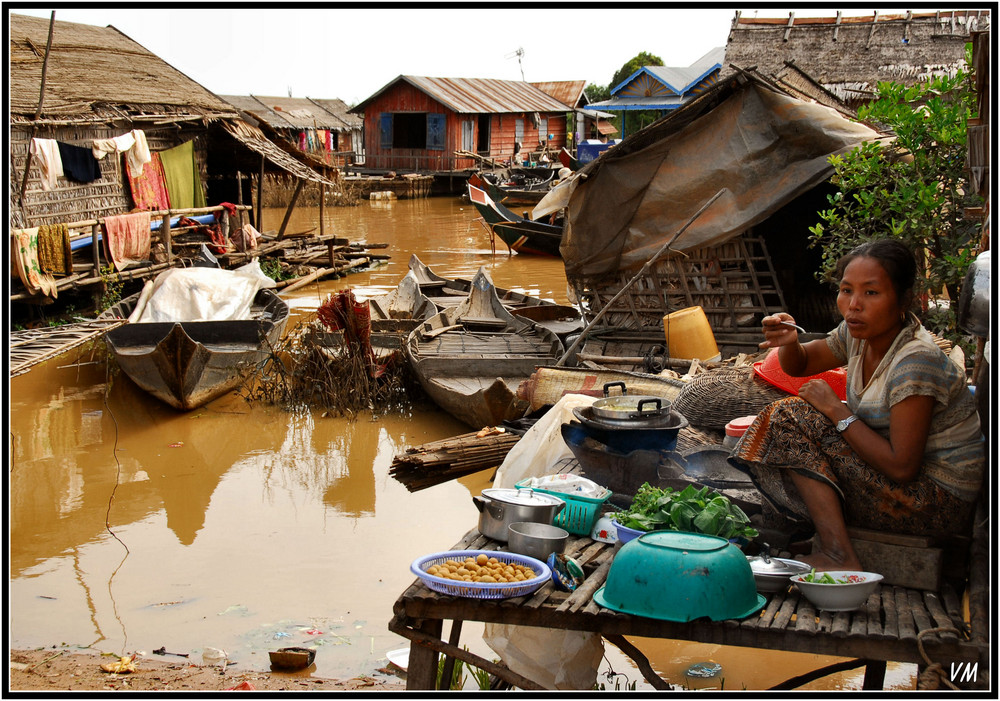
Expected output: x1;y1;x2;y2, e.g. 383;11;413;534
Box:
352;75;573;114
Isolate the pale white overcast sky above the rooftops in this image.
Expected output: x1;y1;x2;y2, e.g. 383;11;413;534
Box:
6;3;916;105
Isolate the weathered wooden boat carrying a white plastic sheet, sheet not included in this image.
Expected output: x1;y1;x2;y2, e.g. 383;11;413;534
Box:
98;289;288;411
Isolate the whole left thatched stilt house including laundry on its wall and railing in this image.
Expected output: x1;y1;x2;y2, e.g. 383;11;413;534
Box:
8;14;333;303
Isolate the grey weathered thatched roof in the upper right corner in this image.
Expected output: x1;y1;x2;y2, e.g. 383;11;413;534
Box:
722;10;990;108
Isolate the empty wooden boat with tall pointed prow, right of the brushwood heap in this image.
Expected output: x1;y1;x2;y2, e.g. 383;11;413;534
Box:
406;268;563;428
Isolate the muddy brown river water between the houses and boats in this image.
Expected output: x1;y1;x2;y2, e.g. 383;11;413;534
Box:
7;197;916;690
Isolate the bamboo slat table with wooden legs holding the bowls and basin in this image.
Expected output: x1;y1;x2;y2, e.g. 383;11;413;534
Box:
389;516;989;690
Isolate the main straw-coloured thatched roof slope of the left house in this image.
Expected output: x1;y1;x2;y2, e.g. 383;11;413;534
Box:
7;14;237;122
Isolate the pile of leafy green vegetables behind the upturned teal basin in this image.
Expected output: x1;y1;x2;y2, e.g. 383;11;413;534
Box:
611;482;757;540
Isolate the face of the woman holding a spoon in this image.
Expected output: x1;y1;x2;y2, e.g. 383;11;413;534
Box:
837;256;903;343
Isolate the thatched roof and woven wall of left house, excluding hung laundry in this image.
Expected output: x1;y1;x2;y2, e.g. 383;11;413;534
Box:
7;14;327;227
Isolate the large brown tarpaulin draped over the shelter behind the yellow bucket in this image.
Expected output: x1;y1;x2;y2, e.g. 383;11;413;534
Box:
559;81;882;277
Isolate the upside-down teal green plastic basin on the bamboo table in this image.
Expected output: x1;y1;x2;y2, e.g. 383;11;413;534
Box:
594;531;766;623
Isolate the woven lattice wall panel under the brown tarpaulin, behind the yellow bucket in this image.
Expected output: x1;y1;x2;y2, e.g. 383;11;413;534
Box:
570;235;785;332
